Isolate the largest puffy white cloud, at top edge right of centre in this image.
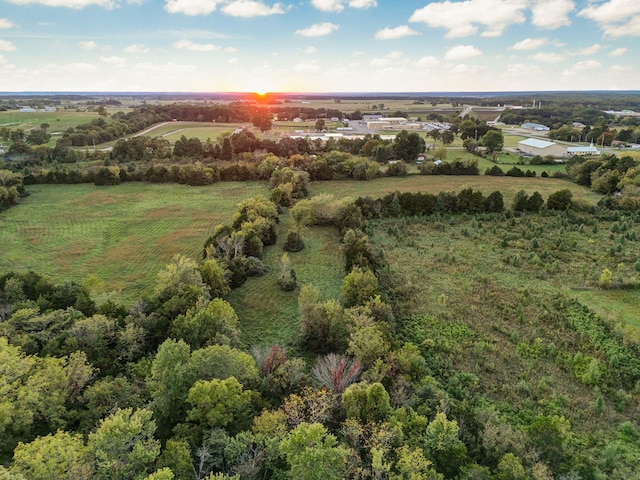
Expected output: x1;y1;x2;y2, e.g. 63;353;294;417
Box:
409;0;528;38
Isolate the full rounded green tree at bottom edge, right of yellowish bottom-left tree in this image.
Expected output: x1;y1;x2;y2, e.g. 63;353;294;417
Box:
87;408;160;480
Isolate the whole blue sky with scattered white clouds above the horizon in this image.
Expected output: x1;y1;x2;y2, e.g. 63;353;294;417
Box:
0;0;640;92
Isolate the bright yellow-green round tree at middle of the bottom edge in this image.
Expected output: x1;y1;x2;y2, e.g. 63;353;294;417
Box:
280;423;348;480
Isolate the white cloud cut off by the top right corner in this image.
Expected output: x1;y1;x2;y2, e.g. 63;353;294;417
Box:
578;0;640;37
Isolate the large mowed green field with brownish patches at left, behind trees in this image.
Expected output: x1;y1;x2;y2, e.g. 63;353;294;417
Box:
0;182;269;303
